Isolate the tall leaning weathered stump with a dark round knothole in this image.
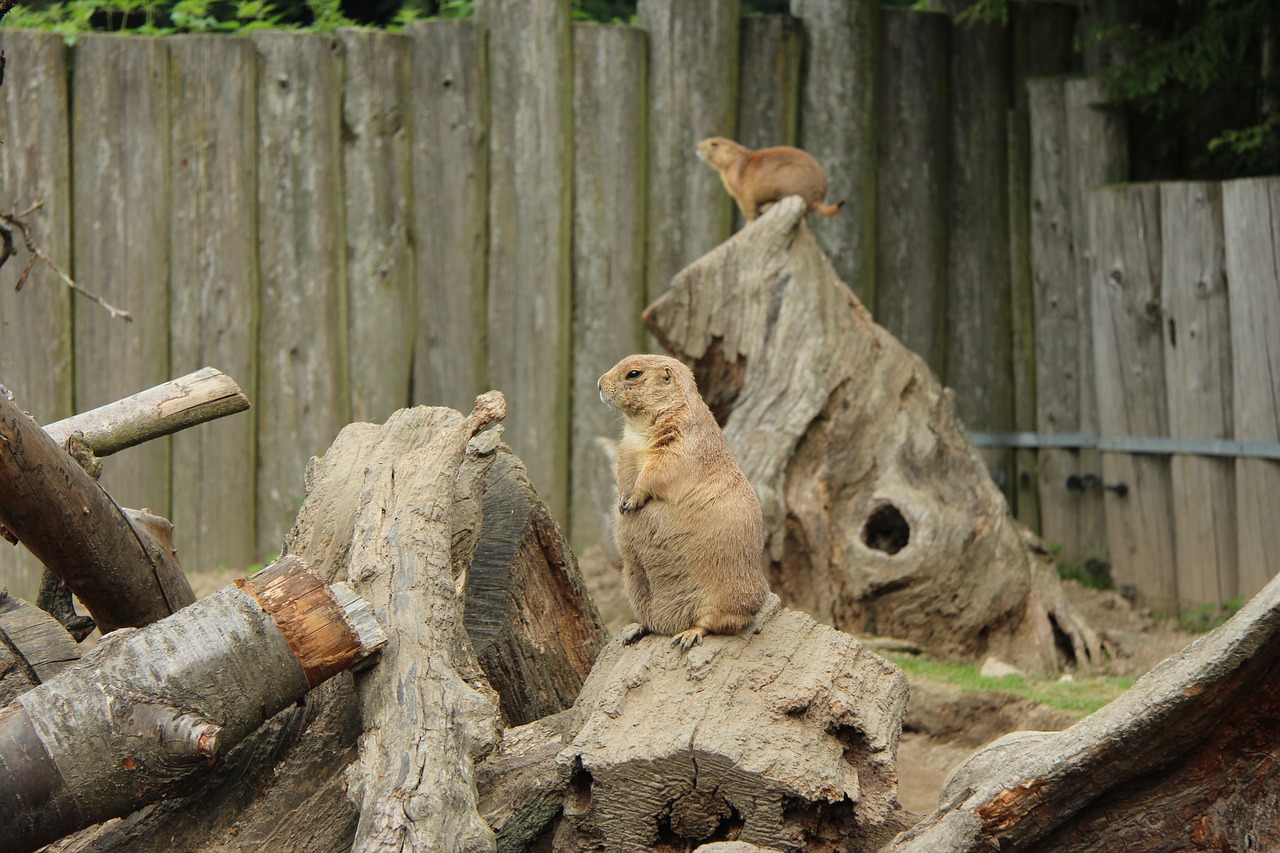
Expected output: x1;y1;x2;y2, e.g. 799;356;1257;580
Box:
645;199;1100;672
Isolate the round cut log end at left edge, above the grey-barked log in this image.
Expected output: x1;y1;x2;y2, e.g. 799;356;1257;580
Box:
0;588;79;706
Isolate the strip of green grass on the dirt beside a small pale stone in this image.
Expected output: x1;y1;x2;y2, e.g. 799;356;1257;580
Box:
887;654;1134;716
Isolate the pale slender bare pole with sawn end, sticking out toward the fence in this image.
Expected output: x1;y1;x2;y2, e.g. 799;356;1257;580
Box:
45;368;250;456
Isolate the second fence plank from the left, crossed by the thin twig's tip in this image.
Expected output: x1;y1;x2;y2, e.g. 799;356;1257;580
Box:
72;35;170;516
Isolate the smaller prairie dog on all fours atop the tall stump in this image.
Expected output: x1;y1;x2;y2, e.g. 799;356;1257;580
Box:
698;136;845;222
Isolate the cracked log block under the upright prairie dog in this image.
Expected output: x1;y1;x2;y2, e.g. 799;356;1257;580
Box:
553;596;910;850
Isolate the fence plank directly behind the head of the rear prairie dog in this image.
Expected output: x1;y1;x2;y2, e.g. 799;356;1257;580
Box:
636;0;741;302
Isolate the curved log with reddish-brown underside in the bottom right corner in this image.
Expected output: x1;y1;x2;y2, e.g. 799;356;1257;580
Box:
884;563;1280;853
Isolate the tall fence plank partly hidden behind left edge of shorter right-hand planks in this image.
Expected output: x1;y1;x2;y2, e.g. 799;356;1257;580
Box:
1064;78;1129;571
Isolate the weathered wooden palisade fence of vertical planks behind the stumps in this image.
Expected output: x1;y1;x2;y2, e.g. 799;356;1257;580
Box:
0;0;1280;606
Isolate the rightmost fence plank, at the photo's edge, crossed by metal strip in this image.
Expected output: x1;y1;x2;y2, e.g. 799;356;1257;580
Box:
1222;178;1280;598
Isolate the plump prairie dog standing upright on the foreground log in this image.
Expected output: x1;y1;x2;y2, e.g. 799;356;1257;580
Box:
598;355;769;651
